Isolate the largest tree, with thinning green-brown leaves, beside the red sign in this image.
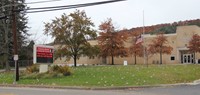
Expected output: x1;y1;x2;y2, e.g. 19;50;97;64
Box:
45;10;97;67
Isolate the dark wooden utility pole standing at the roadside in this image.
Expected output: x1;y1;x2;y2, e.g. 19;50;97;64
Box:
12;0;19;82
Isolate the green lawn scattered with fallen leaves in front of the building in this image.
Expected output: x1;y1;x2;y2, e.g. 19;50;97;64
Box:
0;65;200;87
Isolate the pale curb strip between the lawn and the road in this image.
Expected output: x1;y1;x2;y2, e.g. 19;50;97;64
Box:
0;80;200;90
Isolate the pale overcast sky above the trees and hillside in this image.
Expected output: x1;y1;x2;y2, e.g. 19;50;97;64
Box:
26;0;200;44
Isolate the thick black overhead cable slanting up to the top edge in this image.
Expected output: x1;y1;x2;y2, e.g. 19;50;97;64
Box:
21;0;126;13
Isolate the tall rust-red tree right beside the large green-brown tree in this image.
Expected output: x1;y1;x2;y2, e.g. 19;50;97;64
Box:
98;19;128;65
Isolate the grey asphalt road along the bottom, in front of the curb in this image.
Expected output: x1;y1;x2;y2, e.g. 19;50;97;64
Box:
0;85;200;95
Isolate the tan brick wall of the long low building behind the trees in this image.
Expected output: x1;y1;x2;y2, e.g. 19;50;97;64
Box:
54;25;200;65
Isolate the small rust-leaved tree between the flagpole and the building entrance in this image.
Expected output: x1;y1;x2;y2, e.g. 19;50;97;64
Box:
149;33;173;64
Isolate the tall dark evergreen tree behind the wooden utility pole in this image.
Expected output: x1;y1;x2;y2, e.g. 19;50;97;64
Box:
0;0;29;70
